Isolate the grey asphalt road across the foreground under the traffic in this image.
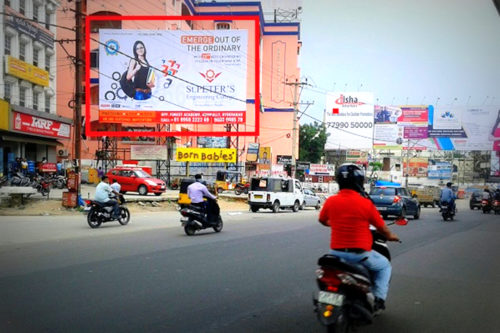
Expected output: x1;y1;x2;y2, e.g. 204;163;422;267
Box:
0;202;500;332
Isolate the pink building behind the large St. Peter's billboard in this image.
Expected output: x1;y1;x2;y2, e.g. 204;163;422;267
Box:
57;0;301;175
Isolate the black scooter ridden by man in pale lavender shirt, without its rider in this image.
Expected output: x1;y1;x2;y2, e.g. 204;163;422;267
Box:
180;199;223;236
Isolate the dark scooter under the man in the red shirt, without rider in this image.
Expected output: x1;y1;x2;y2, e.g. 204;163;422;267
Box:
313;218;408;333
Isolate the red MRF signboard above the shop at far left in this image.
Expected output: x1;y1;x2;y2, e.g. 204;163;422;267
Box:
12;111;71;139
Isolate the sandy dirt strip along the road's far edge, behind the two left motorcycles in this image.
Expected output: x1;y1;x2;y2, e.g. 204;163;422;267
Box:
0;198;248;216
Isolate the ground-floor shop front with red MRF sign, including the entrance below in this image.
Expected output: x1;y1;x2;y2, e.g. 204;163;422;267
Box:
0;105;72;175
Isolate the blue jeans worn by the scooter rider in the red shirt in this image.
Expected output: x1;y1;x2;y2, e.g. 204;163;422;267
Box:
330;250;392;300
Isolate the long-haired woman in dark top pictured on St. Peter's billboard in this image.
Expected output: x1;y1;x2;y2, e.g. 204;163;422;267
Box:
127;40;155;100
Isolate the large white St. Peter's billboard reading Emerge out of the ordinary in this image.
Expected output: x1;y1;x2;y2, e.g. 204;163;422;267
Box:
99;29;248;124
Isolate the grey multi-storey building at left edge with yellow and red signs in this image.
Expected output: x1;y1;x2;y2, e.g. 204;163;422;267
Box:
0;0;72;173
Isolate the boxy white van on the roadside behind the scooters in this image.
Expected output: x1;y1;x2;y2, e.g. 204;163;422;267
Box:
248;177;304;213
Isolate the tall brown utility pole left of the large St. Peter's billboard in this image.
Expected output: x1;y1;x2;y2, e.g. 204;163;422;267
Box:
74;0;87;198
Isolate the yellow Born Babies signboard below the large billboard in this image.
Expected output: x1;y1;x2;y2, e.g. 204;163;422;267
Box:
175;148;237;163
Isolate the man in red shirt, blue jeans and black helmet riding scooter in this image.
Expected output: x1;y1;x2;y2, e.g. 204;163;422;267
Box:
319;164;399;310
